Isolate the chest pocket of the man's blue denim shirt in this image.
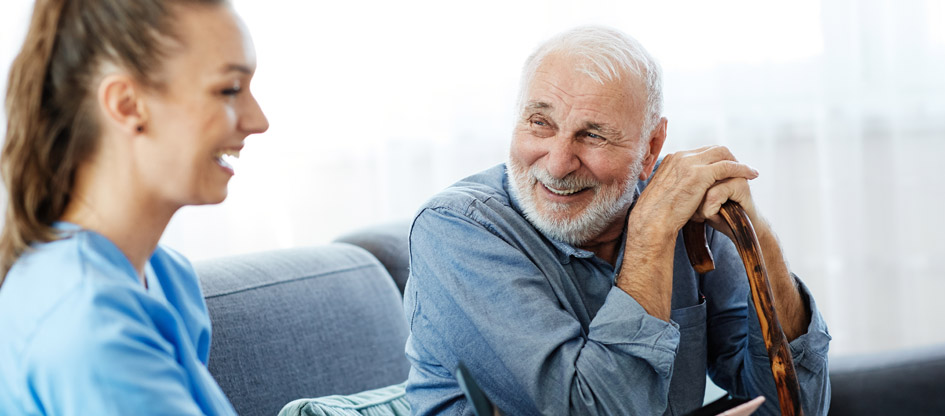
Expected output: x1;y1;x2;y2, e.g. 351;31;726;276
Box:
666;299;707;415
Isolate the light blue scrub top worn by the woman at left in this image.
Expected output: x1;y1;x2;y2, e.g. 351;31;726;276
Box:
0;223;236;415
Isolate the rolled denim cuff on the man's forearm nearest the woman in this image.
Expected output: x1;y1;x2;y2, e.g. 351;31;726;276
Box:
588;286;679;376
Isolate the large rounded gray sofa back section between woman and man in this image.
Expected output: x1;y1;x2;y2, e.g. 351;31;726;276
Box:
194;243;409;416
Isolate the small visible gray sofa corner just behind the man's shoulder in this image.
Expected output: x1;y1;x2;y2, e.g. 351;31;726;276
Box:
335;220;410;294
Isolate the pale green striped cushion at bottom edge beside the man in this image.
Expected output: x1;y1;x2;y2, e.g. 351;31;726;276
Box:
279;382;410;416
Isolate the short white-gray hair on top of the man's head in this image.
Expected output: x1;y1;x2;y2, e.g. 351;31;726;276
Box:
518;26;663;140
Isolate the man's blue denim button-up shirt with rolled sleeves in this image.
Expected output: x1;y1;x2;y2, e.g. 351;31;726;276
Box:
404;165;830;415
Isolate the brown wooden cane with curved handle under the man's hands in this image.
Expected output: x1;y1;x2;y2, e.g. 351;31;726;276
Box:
683;201;803;416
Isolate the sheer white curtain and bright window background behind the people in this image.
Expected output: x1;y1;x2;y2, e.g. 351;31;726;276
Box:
0;0;945;354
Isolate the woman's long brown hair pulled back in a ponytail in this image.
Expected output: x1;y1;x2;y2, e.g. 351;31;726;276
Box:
0;0;227;284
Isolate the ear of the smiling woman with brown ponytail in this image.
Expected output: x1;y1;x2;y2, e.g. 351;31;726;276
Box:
97;73;148;135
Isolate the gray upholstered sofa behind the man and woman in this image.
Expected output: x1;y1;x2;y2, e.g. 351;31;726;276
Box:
195;222;945;416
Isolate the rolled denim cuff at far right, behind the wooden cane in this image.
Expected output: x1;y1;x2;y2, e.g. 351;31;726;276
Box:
748;274;832;373
